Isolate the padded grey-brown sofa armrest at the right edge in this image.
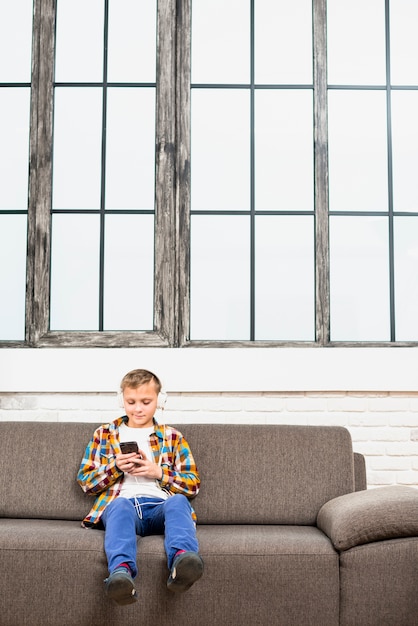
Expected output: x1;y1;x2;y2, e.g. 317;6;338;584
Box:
317;485;418;551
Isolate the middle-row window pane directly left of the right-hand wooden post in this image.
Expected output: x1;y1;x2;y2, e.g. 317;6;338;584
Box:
255;89;313;211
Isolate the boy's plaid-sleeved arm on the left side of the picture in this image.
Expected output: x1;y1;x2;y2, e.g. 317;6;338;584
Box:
77;432;123;495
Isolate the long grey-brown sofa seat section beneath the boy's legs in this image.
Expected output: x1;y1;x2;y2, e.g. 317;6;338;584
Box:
0;518;339;626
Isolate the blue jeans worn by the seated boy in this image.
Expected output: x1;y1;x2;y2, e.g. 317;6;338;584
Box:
101;494;198;577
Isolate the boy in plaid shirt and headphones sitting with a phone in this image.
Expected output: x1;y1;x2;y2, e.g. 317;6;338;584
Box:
77;369;203;605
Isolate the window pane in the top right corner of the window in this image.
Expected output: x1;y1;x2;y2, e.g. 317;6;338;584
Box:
390;0;418;85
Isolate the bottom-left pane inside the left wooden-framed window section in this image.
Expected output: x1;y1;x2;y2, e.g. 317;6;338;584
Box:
51;215;100;330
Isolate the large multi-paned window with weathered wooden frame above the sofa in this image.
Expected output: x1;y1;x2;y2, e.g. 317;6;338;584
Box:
0;0;418;347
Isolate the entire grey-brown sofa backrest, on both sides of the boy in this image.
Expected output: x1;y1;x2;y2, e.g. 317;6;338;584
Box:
0;422;354;525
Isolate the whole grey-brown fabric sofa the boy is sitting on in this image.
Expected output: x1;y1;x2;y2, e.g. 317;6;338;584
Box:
0;422;418;626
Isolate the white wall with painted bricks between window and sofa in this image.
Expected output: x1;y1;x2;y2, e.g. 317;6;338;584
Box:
0;348;418;486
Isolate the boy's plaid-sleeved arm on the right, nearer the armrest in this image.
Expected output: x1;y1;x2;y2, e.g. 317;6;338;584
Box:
160;436;200;498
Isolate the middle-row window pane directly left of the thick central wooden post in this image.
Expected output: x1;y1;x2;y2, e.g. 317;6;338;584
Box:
106;88;155;209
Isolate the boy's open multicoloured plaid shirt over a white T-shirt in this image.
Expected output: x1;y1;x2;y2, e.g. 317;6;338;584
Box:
77;416;200;526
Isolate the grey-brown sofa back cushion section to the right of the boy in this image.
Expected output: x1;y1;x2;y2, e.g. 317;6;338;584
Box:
178;424;354;525
